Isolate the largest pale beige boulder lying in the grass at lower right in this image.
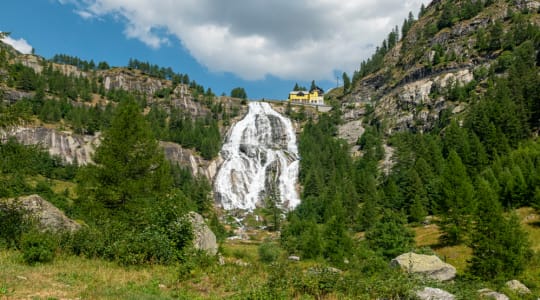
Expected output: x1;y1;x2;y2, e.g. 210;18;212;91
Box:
390;252;456;281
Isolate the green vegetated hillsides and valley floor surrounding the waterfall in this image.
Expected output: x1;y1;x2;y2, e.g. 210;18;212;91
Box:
0;0;540;299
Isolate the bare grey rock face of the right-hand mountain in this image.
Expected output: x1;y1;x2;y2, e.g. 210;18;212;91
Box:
342;0;540;133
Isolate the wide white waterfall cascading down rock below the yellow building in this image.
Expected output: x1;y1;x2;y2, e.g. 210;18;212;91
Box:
214;102;300;210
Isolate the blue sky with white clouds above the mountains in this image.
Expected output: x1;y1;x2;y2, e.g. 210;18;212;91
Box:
0;0;428;99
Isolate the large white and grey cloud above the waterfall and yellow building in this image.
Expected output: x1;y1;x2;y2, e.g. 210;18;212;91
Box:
59;0;426;80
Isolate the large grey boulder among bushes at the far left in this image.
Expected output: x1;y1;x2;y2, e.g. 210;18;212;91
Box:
8;195;81;232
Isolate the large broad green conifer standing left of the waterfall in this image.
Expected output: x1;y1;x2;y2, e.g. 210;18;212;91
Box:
81;98;172;209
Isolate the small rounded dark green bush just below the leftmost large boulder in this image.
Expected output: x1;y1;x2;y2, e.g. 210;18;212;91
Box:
21;230;58;265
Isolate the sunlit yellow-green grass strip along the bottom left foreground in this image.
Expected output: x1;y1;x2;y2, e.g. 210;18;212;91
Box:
0;242;266;299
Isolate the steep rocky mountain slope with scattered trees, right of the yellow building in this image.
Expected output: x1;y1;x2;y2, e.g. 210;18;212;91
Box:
342;0;540;133
